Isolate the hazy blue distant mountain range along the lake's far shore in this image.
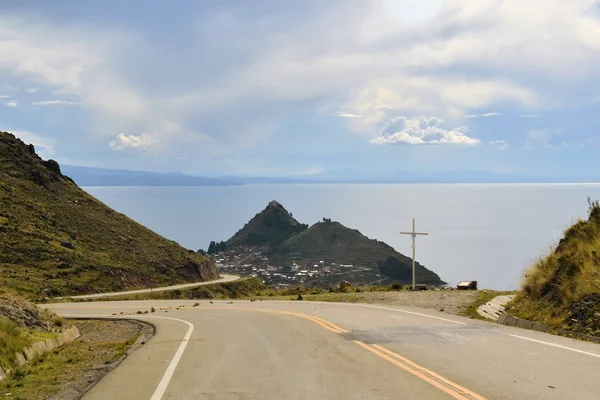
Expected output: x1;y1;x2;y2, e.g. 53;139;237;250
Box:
62;165;600;186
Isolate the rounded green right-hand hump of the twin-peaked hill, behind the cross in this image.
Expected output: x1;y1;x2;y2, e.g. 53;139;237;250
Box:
273;221;444;285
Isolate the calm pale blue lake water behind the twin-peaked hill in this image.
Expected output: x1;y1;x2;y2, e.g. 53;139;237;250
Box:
85;184;600;289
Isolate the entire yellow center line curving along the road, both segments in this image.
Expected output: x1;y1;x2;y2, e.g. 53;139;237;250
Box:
55;305;487;400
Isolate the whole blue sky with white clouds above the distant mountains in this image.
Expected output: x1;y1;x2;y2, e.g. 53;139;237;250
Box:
0;0;600;177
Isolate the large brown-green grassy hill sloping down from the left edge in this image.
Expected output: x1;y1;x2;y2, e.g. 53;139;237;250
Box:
0;132;218;297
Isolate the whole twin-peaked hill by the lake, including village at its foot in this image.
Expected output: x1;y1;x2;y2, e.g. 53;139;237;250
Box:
216;201;445;286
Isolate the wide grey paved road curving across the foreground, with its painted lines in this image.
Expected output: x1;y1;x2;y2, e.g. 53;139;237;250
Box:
47;300;600;400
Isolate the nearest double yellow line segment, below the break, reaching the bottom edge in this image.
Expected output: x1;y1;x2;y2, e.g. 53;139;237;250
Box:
353;340;486;400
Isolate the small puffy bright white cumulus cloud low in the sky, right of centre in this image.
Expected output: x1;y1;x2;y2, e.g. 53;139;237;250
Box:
369;117;481;146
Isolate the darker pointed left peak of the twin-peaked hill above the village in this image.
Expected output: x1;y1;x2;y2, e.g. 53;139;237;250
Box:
226;201;308;248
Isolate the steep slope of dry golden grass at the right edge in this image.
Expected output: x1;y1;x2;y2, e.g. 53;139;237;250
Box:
509;199;600;335
